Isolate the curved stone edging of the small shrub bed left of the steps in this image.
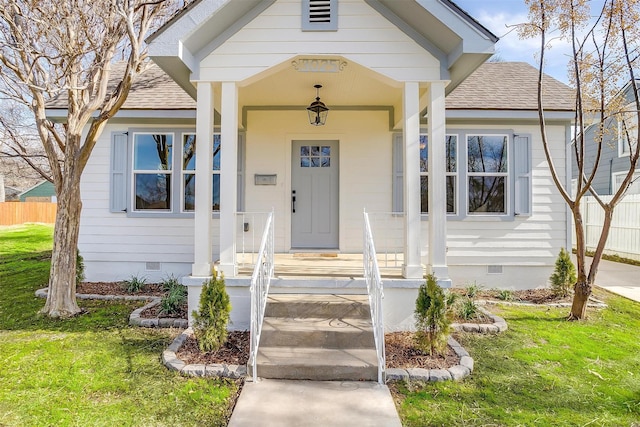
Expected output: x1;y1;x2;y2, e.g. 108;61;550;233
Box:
162;328;247;379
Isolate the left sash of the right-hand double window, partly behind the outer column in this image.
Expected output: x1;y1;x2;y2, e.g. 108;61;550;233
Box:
420;135;458;214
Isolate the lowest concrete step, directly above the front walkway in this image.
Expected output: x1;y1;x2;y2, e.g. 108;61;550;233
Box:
249;347;378;381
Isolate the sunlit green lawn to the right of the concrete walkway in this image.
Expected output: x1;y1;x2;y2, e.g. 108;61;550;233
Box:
395;294;640;427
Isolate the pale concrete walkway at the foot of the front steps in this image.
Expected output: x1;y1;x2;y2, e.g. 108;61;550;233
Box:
229;379;402;427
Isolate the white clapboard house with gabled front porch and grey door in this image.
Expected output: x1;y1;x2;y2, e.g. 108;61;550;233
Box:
48;0;574;329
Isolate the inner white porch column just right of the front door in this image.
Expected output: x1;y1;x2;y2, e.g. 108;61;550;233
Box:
402;82;424;279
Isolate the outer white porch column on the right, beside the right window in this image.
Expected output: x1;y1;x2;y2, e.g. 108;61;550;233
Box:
427;82;451;287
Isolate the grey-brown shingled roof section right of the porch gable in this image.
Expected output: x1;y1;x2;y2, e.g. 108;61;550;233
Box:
446;62;575;111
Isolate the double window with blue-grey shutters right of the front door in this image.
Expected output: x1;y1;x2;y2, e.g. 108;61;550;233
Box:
391;129;533;221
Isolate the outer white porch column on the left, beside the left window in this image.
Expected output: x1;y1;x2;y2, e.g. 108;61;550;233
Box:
191;82;213;277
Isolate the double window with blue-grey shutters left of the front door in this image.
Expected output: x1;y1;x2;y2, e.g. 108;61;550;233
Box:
109;128;245;217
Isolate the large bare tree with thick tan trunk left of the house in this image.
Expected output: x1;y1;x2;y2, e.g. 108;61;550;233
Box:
0;0;189;317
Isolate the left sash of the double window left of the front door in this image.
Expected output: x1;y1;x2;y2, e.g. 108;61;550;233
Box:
133;133;174;211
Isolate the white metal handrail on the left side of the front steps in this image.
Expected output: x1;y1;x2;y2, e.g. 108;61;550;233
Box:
249;212;274;382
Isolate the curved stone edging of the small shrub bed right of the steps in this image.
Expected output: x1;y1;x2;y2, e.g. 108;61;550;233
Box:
386;337;473;382
